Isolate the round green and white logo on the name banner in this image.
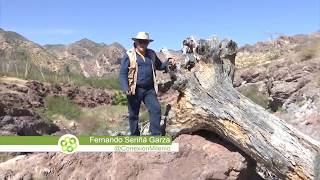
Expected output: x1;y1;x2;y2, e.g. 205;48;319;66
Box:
58;134;79;154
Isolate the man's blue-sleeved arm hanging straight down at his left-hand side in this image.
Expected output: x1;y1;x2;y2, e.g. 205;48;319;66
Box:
119;54;130;92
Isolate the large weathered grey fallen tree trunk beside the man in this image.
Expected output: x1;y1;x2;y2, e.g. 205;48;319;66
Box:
166;38;320;179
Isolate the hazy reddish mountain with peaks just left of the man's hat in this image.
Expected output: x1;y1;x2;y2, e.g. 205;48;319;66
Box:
44;39;125;77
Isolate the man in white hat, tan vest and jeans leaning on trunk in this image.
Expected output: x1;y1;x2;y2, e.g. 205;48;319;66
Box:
119;32;176;136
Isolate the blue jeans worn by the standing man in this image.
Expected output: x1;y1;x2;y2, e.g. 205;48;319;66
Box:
127;87;162;136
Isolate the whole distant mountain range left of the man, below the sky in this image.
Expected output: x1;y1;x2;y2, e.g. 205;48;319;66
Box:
0;29;125;77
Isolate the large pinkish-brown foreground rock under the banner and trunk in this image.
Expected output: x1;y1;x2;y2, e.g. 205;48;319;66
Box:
0;135;257;180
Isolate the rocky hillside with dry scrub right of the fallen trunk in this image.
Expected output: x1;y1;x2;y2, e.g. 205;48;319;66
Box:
234;32;320;140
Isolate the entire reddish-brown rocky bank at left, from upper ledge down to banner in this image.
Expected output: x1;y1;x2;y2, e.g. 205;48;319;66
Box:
0;77;114;135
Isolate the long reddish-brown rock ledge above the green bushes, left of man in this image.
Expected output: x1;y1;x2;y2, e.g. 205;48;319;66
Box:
0;77;114;109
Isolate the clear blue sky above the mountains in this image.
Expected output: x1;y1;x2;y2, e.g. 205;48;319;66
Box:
0;0;320;50
